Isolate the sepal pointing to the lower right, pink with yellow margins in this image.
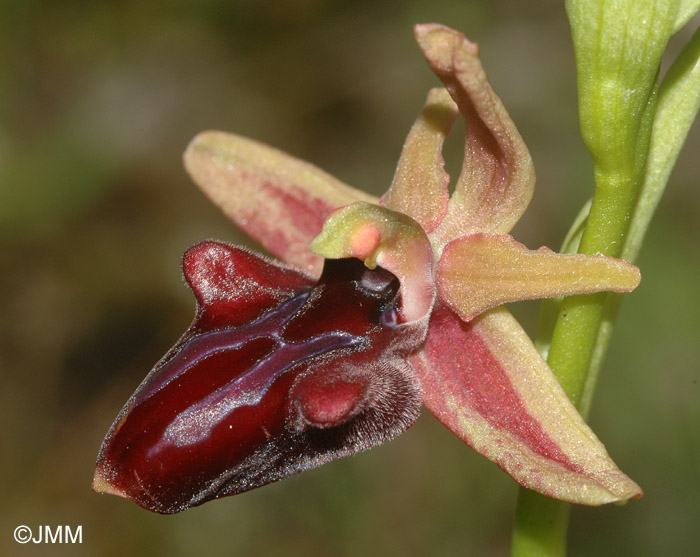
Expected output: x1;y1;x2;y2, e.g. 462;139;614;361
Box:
411;303;642;505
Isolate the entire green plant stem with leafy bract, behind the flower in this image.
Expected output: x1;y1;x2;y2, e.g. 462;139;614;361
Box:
512;0;700;557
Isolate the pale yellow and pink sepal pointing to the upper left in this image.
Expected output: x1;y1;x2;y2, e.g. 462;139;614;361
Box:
184;131;377;275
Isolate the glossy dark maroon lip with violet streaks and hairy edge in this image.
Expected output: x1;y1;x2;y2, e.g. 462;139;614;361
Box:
95;241;422;513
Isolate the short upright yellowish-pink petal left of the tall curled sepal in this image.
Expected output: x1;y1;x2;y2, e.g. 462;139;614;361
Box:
381;88;457;232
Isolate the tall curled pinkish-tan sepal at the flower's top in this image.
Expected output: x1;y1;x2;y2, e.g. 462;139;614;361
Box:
415;24;535;245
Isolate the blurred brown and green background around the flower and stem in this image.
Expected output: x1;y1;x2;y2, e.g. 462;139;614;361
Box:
0;0;700;556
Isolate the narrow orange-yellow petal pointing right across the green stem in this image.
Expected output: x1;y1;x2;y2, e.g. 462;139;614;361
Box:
437;234;640;321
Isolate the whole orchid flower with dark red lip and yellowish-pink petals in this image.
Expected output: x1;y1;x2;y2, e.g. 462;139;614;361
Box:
94;24;641;513
